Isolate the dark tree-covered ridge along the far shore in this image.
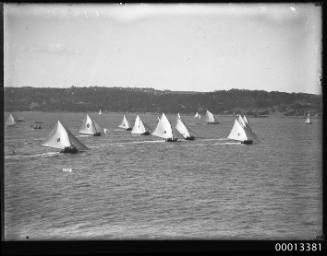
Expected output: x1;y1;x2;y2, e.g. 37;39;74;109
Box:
4;87;322;115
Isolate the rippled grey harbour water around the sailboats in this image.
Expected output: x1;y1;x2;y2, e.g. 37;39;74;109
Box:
4;112;322;240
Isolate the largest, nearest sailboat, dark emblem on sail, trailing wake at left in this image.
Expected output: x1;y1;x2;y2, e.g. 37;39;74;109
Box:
42;120;88;153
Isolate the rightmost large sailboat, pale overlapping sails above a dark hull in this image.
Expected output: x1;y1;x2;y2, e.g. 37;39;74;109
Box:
227;115;258;144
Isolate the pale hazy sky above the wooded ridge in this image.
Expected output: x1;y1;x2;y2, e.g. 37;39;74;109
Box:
4;3;322;94
